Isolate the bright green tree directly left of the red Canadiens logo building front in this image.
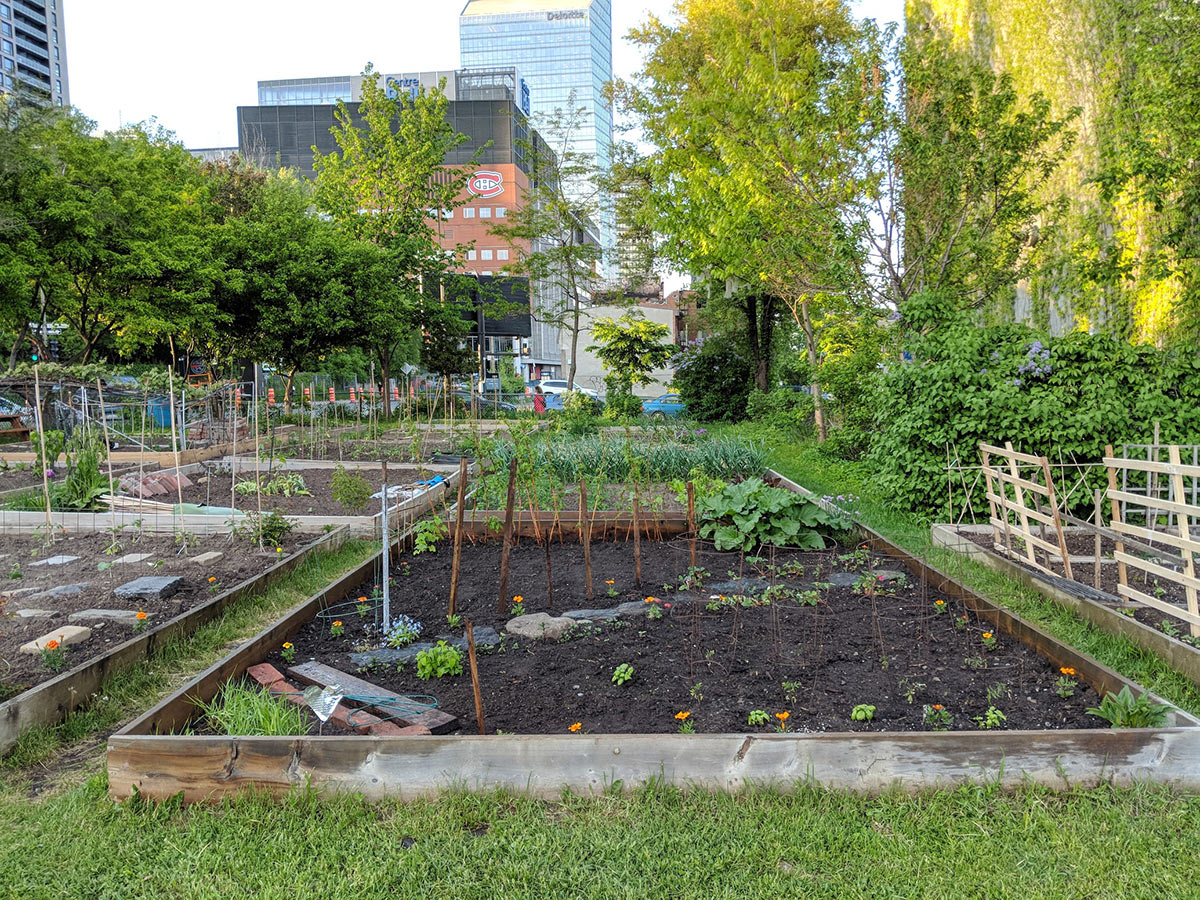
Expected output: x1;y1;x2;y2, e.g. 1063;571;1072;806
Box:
313;66;478;415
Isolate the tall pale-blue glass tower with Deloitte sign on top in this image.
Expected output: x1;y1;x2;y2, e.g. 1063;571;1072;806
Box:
458;0;616;248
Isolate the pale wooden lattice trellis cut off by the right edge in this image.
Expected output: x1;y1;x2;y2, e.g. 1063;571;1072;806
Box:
1104;444;1200;637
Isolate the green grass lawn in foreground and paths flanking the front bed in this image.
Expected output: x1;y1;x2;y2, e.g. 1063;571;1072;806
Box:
0;440;1200;900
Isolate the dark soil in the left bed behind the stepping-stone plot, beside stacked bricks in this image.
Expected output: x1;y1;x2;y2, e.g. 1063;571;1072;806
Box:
169;464;433;516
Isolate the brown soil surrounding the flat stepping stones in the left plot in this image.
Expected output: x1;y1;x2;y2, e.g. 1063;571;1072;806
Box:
0;533;306;701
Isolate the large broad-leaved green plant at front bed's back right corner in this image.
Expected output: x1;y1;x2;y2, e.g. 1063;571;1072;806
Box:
696;478;852;551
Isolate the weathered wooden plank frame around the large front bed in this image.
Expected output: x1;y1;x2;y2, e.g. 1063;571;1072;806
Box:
108;479;1200;803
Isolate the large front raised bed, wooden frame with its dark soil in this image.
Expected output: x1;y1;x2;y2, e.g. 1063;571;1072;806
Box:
109;504;1200;800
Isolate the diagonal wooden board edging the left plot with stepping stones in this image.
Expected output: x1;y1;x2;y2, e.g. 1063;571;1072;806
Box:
0;528;348;756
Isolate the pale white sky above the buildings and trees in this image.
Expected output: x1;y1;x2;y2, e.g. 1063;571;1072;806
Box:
59;0;904;148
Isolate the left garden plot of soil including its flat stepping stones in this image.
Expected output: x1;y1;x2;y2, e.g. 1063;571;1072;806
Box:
0;530;300;702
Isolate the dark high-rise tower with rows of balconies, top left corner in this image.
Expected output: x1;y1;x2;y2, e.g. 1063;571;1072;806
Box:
0;0;71;107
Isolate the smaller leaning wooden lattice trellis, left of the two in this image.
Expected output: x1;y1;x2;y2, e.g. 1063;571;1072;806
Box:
979;442;1074;578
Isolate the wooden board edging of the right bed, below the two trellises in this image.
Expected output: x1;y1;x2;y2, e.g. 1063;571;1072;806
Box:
930;524;1200;685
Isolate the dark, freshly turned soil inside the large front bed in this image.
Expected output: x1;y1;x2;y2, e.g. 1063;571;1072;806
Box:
268;540;1104;733
